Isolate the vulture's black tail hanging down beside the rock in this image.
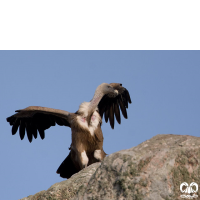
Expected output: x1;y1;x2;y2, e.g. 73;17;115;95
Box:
56;152;79;178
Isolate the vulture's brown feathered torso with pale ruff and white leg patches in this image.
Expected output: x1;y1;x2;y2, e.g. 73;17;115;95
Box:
61;102;106;178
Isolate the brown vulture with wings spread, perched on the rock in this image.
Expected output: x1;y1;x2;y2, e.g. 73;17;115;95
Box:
7;83;131;178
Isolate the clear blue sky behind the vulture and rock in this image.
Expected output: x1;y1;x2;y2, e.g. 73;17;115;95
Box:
0;51;200;200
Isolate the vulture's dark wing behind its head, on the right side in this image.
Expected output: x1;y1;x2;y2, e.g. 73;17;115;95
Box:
98;83;131;129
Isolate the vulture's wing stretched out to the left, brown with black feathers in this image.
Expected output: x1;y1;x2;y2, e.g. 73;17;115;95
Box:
7;106;70;142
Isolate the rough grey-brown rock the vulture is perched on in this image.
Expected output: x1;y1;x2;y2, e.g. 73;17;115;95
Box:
22;135;200;200
